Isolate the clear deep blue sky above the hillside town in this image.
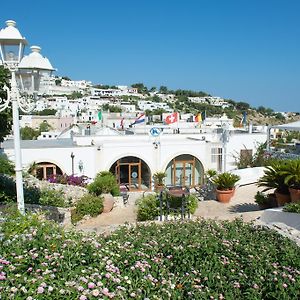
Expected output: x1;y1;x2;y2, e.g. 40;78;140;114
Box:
0;0;300;112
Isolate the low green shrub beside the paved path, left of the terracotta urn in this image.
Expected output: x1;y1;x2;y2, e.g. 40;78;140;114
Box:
71;194;103;223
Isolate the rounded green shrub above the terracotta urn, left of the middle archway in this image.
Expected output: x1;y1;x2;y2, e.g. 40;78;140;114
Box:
87;171;120;196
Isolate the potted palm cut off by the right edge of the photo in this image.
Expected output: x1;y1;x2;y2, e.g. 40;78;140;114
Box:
282;159;300;202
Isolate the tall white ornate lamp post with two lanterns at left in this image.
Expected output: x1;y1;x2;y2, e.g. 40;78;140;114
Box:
0;20;54;214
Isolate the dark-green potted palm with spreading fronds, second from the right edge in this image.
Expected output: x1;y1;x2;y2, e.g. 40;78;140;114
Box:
258;161;291;206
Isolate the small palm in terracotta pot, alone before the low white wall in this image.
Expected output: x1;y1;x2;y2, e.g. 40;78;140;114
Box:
212;172;240;203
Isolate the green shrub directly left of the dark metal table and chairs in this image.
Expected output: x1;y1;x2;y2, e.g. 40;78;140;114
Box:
136;195;159;221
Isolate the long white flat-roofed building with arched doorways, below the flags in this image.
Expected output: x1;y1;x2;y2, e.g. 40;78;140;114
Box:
3;124;267;191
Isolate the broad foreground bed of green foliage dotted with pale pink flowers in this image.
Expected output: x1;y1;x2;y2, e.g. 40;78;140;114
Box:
0;211;300;300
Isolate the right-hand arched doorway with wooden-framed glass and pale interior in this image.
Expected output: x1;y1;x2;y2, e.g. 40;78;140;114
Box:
165;154;204;187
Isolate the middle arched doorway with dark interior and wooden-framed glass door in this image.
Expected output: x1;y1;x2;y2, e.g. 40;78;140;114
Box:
110;156;151;191
